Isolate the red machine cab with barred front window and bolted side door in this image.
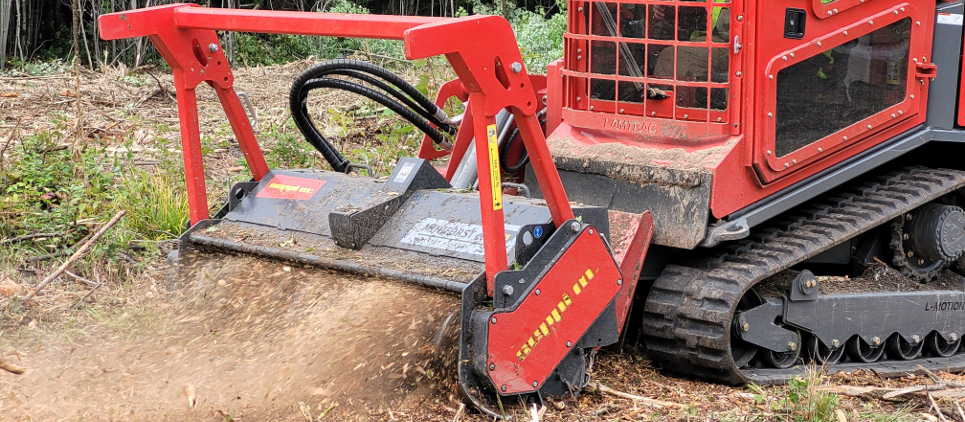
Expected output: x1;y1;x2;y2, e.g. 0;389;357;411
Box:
549;0;935;221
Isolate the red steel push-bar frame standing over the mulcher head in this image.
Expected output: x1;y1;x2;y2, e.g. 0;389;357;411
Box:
98;4;573;296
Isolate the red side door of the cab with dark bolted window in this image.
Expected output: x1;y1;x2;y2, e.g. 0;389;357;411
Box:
753;0;935;184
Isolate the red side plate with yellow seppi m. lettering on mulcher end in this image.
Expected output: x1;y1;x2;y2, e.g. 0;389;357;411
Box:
488;227;623;395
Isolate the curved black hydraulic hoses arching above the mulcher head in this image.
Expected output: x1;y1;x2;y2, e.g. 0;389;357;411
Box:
289;59;457;172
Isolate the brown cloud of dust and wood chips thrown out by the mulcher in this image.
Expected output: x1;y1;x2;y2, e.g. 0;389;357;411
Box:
0;252;459;421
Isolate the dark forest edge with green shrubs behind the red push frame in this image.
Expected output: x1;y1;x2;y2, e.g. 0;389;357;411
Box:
0;0;566;74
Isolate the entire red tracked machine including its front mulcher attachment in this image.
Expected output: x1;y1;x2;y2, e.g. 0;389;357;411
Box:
100;0;965;415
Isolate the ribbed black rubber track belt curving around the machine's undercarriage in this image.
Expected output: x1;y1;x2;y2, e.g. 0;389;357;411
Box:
643;167;965;384
